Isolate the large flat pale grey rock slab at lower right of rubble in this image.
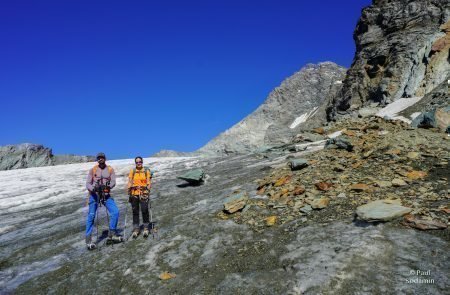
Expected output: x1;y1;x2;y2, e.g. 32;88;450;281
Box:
356;200;412;222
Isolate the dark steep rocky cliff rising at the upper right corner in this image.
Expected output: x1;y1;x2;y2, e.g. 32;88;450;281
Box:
327;0;450;119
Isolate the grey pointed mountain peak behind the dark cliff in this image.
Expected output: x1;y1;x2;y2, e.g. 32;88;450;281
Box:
198;62;345;154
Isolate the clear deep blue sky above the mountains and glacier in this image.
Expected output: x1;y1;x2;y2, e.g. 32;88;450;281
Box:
0;0;371;158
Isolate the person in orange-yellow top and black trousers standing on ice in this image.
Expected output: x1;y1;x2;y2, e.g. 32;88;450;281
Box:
127;156;152;238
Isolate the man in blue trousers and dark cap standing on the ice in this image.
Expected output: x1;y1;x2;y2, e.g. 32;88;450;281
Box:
86;153;123;250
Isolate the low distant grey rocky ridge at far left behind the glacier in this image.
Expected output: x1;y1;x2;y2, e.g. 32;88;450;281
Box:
0;143;94;170
